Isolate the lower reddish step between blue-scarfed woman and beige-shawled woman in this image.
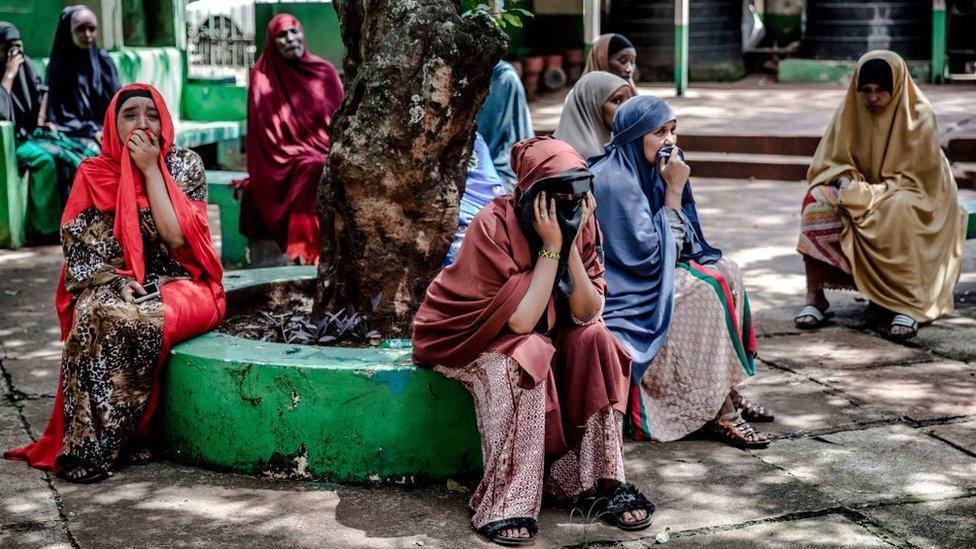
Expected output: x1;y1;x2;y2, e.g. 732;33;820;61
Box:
686;151;811;181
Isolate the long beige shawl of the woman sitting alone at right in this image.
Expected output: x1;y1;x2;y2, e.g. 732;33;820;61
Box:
807;50;966;322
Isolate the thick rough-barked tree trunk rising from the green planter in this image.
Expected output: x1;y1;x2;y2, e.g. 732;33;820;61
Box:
316;0;507;337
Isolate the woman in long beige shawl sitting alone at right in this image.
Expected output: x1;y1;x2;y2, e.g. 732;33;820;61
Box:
795;51;966;340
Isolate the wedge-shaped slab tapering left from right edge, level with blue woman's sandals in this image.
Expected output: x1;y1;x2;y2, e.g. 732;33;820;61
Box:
816;360;976;421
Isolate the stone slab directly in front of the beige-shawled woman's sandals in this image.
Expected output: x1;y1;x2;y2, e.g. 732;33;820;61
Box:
759;326;933;375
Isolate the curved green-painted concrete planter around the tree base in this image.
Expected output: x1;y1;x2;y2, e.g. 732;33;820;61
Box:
159;267;481;483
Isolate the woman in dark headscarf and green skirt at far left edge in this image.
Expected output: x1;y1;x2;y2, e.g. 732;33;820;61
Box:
0;21;94;243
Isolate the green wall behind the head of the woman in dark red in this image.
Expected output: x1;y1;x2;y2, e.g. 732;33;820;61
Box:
254;2;346;68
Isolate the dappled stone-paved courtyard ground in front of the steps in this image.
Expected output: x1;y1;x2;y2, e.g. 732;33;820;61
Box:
0;79;976;549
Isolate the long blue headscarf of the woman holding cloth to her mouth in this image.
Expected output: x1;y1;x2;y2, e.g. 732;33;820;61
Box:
590;95;722;383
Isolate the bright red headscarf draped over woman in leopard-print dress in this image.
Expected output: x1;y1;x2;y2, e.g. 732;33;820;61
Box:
4;84;226;470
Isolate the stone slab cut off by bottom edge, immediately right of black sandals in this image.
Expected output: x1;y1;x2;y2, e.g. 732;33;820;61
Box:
647;515;891;549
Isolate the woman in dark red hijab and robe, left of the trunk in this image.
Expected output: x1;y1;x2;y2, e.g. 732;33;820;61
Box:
240;13;343;264
